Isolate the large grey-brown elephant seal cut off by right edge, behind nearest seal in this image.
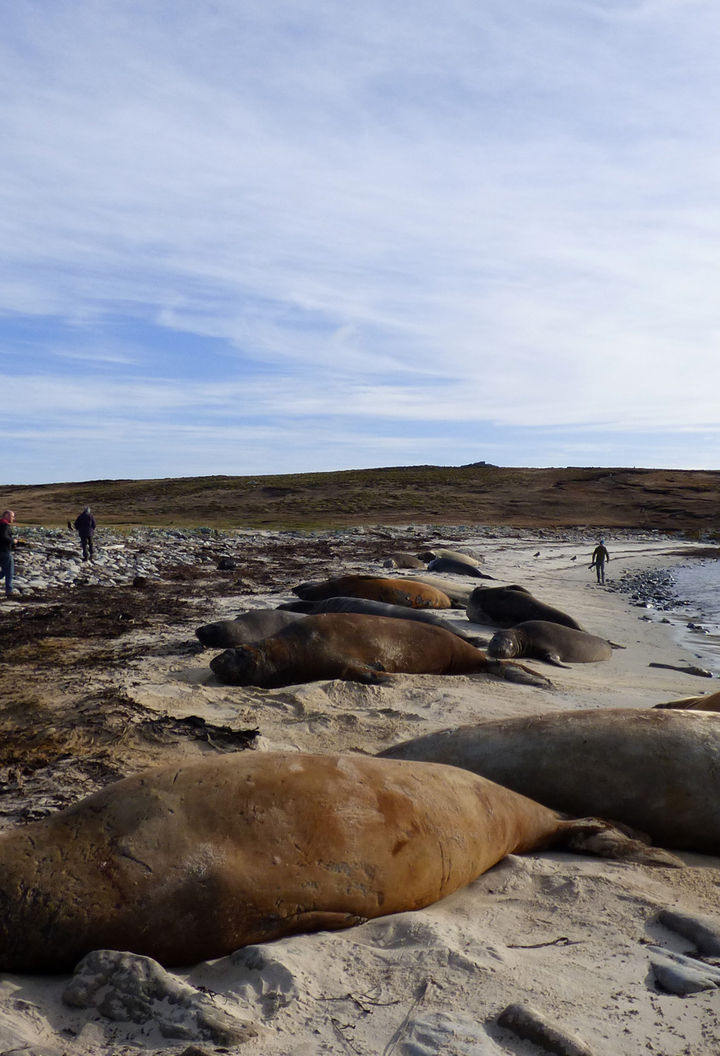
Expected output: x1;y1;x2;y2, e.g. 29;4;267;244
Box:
380;708;720;854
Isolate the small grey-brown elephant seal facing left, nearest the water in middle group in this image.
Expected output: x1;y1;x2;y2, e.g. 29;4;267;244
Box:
488;620;612;667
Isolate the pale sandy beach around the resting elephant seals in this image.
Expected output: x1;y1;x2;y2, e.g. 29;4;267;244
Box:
0;529;720;1056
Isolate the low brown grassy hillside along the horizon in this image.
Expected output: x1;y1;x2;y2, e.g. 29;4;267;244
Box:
0;463;720;535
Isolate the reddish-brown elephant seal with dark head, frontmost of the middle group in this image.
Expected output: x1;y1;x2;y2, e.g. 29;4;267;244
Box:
210;612;551;689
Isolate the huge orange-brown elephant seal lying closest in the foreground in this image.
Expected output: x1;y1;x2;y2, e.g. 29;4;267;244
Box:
0;752;671;973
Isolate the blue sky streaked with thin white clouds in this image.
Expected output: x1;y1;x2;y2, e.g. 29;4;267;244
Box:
0;0;720;485
